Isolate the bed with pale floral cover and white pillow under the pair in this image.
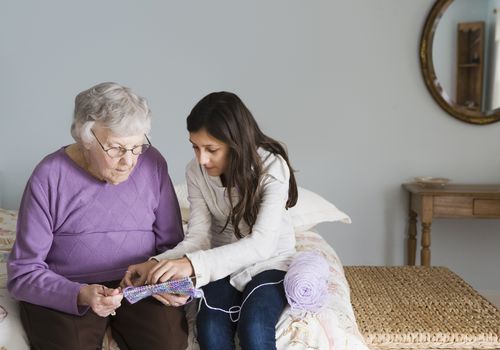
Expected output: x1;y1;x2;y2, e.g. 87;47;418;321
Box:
0;184;368;350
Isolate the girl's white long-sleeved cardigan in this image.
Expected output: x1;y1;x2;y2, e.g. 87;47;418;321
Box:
154;149;295;291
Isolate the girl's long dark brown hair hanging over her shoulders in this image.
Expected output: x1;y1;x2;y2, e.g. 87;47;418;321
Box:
187;91;298;238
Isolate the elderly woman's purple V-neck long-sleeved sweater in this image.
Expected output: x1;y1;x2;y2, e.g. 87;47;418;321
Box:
7;147;184;315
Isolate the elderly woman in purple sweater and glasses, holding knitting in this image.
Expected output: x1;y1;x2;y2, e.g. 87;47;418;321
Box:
8;83;187;350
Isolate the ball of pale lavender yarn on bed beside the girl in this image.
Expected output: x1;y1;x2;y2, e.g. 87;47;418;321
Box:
283;252;329;313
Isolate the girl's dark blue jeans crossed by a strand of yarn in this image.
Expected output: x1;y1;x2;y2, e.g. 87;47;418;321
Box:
196;270;287;350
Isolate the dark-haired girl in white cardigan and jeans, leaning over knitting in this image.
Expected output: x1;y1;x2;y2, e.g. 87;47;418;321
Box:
124;92;297;350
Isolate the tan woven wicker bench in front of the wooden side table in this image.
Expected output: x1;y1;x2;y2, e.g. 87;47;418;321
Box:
345;266;500;349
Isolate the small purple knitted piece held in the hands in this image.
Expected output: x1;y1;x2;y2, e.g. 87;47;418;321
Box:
123;277;203;304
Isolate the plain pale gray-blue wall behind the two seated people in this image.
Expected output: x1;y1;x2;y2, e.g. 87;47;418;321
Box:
0;0;500;290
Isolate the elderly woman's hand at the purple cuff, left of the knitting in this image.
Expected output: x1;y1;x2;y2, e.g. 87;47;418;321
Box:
77;284;123;317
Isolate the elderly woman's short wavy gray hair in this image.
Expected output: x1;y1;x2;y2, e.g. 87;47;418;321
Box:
71;82;151;143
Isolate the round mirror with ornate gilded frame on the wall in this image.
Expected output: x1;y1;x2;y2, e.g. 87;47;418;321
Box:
420;0;500;124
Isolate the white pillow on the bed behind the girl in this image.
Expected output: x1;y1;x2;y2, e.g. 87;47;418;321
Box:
174;183;351;232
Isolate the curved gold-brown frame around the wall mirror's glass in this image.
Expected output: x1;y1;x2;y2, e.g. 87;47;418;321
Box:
420;0;500;125
